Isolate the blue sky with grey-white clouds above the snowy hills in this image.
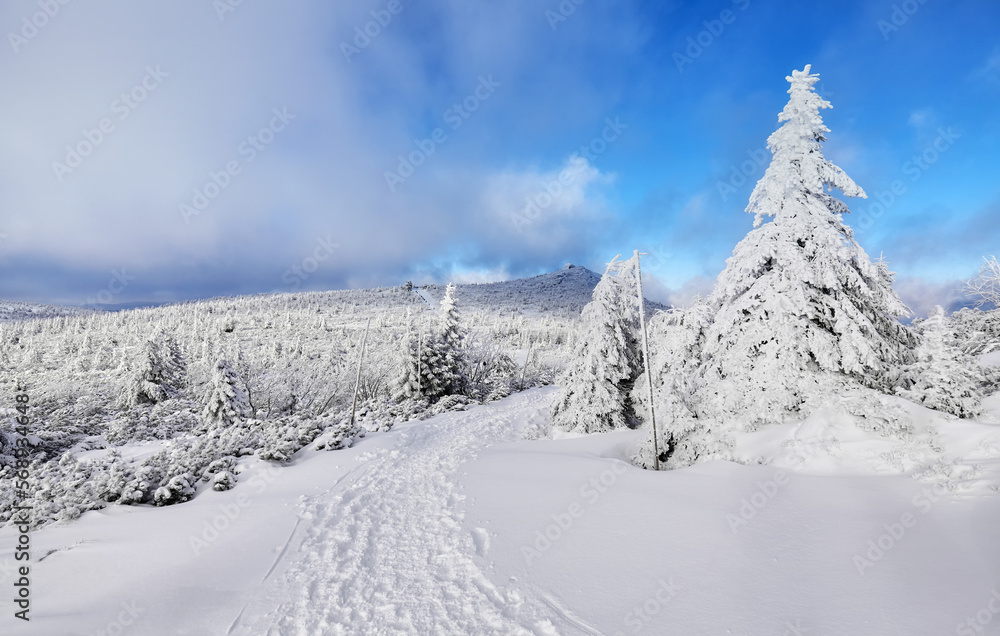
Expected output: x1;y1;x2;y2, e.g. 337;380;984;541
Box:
0;0;1000;313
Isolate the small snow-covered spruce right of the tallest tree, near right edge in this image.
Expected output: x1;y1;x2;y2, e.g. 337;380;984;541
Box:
898;306;983;418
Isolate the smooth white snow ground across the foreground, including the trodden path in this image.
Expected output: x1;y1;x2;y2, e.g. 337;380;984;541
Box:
0;387;1000;636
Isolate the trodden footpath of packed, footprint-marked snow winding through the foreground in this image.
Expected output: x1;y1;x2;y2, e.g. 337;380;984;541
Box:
229;392;573;636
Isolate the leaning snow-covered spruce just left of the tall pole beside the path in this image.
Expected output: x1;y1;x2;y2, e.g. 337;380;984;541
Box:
552;259;641;433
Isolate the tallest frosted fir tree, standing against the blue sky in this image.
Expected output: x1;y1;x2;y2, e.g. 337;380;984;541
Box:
703;65;914;428
